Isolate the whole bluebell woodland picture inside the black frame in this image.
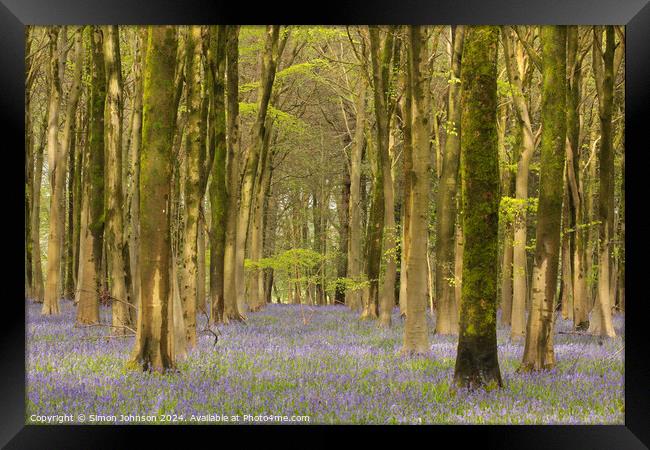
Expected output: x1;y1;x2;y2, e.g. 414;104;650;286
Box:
21;25;624;425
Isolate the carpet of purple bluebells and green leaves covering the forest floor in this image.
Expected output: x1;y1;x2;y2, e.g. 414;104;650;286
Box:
26;301;625;424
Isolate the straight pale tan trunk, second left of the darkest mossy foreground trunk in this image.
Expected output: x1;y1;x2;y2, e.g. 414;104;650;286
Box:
403;26;431;354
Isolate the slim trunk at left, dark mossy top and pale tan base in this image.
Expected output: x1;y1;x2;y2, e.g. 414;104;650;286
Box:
75;26;106;324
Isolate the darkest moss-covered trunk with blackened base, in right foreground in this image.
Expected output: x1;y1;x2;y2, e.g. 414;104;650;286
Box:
450;26;501;388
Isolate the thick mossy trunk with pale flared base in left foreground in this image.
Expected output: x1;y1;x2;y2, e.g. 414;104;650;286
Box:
132;26;177;372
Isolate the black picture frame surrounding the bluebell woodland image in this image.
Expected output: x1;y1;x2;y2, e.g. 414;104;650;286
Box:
0;0;650;450
